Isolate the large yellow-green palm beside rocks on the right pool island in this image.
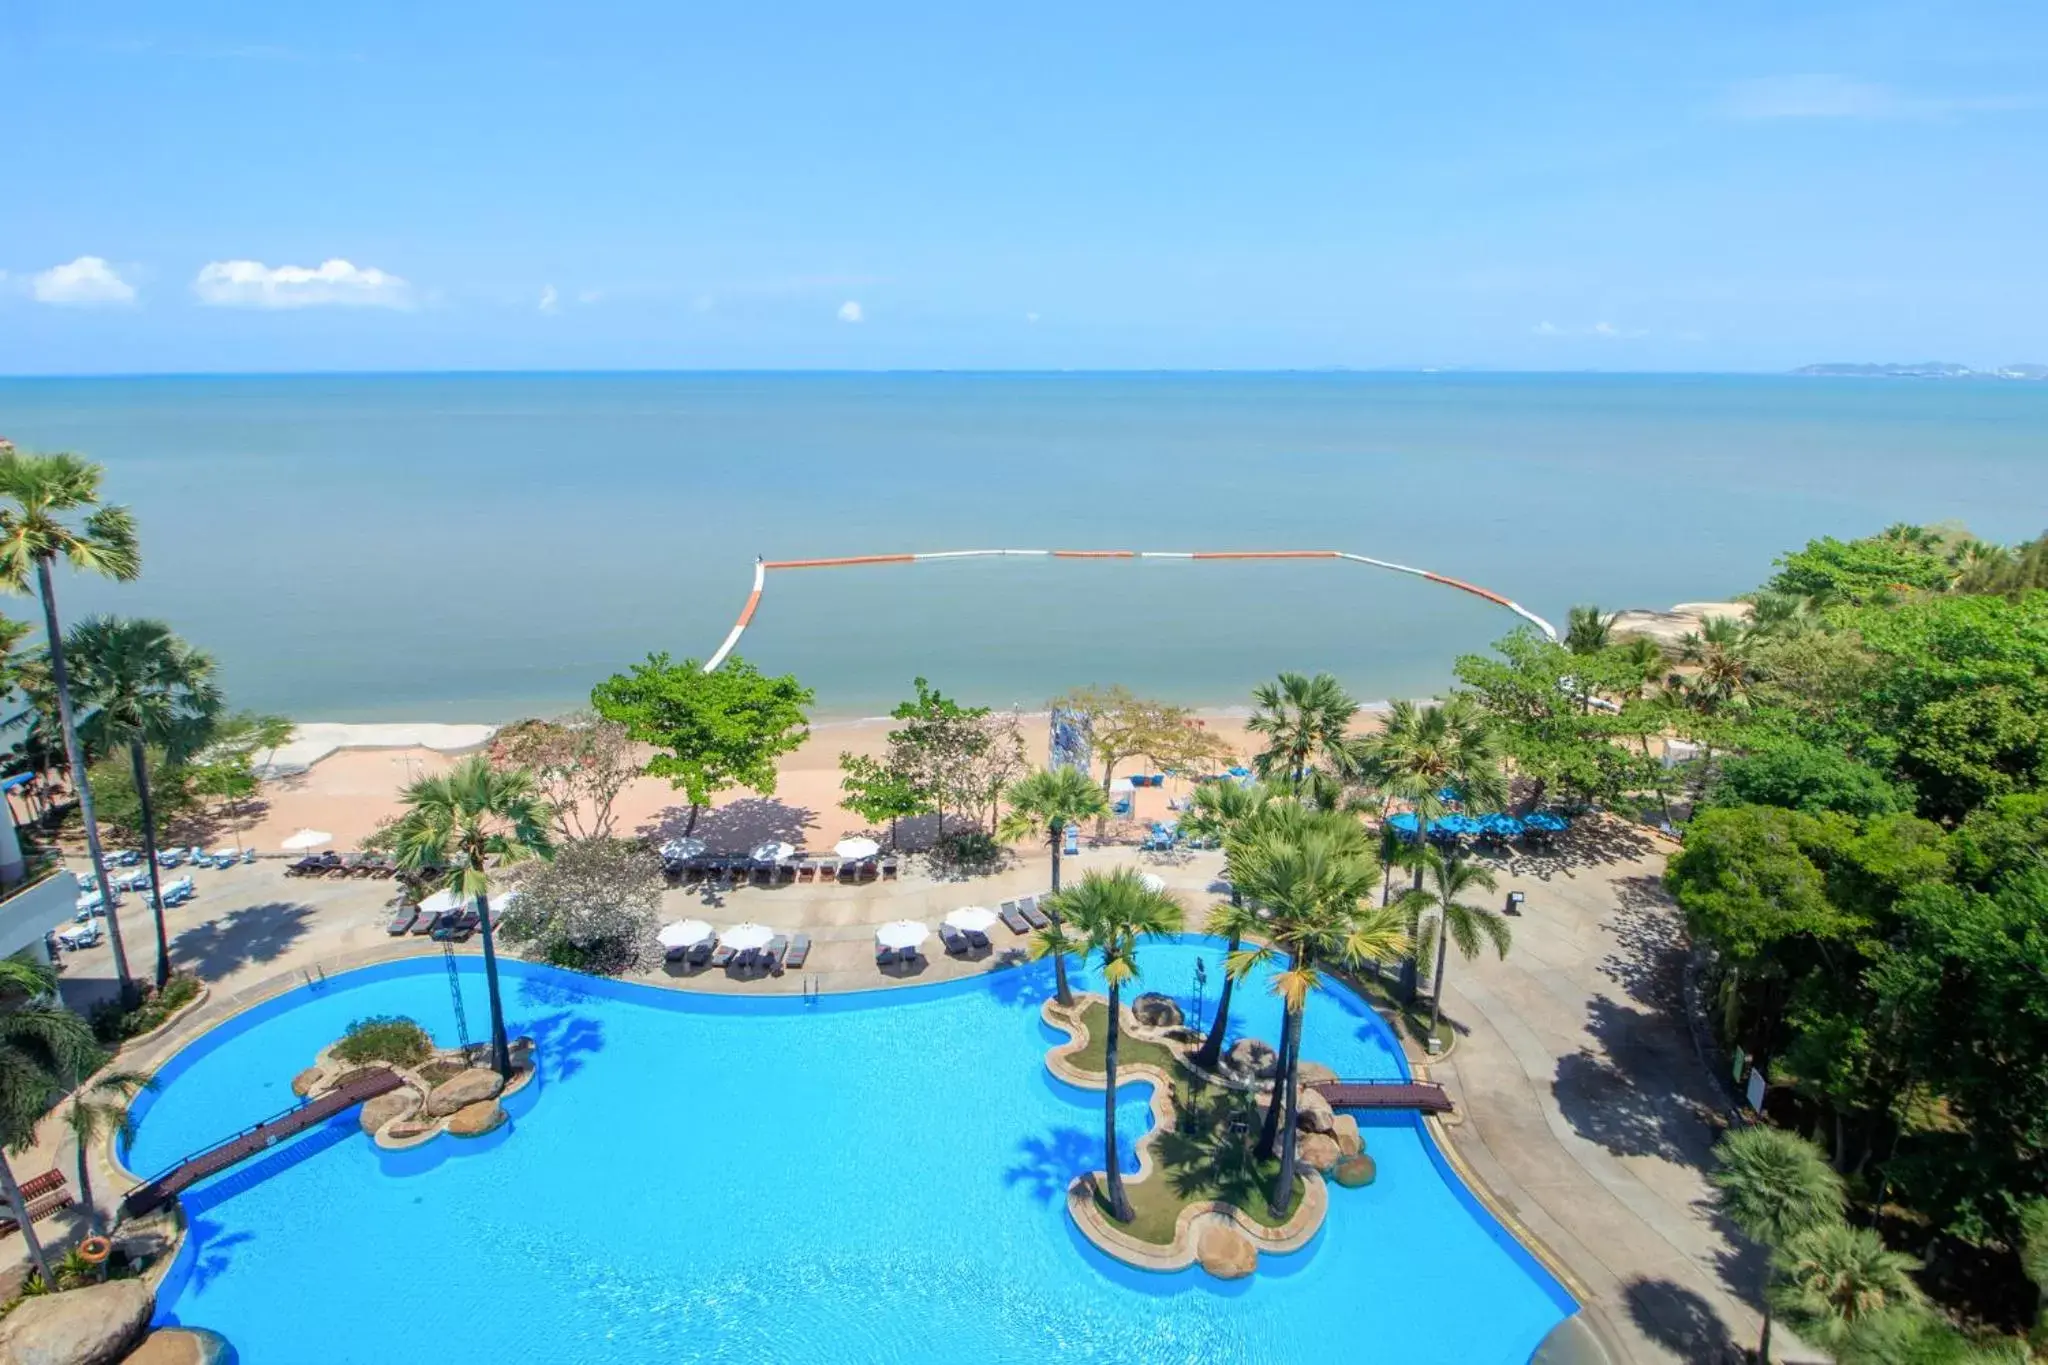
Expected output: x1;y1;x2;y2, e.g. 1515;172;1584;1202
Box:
1229;804;1409;1209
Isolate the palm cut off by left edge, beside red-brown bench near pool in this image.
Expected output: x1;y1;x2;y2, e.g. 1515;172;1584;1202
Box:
0;958;100;1289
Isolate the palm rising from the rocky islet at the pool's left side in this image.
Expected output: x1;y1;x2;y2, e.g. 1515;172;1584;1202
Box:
393;753;555;1078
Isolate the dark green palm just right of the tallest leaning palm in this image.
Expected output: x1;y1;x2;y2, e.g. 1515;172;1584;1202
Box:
66;616;221;990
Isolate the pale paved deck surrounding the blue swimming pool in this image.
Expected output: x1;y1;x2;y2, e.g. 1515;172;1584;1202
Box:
24;823;1806;1365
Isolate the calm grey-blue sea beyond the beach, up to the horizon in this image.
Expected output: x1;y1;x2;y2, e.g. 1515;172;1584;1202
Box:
0;375;2048;720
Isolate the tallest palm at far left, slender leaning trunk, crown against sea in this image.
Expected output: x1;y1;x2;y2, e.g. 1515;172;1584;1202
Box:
0;446;141;999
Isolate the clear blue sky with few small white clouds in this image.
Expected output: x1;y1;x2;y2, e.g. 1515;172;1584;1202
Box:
0;0;2048;372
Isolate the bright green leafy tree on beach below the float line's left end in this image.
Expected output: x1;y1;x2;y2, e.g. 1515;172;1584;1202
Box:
590;655;817;833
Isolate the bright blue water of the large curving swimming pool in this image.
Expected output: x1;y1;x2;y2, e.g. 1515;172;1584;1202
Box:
129;937;1573;1365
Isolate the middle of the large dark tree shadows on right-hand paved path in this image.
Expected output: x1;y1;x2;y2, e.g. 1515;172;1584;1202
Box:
1550;997;1716;1166
